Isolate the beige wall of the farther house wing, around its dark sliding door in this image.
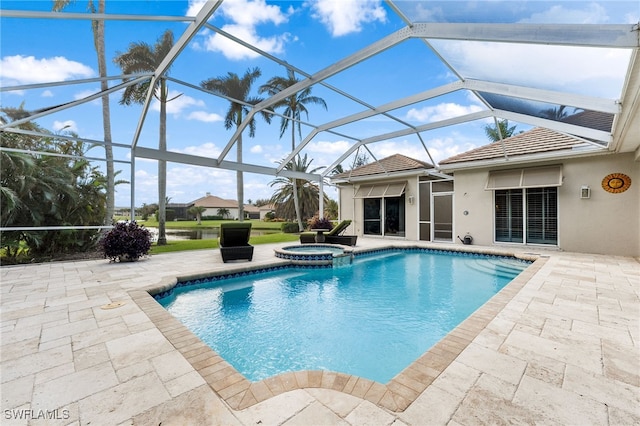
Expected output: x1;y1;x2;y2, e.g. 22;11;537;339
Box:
338;176;418;240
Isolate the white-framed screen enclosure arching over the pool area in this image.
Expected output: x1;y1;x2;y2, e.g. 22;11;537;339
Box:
0;0;640;233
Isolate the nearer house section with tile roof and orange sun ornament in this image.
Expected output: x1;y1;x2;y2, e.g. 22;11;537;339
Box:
440;128;640;256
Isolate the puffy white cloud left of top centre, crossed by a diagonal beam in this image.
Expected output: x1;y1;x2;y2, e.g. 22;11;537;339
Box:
187;0;292;60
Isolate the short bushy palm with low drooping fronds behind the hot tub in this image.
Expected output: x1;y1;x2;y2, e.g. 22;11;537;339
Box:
269;154;329;220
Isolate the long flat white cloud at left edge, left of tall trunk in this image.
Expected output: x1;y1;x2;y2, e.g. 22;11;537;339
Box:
0;55;95;84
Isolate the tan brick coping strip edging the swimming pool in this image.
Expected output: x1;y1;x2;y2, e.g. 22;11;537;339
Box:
129;245;548;412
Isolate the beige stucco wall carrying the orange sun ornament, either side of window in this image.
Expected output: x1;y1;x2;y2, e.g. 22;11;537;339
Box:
454;153;640;256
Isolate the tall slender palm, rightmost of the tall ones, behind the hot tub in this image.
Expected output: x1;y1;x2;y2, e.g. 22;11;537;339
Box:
260;69;327;231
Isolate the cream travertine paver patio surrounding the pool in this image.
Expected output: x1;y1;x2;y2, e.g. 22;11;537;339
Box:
0;238;640;425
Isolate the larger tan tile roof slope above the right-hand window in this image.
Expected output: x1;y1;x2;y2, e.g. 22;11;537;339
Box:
440;127;584;164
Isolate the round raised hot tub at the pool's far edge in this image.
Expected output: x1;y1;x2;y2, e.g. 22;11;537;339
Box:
274;244;353;266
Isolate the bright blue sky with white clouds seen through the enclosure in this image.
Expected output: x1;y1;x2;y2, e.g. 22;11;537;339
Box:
0;0;640;206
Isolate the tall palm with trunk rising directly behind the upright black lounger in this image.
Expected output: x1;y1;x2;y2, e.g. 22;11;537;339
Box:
200;67;271;221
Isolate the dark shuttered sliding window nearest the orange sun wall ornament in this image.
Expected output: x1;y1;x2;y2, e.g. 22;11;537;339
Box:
495;187;558;245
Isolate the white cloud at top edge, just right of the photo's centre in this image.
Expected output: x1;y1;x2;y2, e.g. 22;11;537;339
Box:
311;0;387;37
